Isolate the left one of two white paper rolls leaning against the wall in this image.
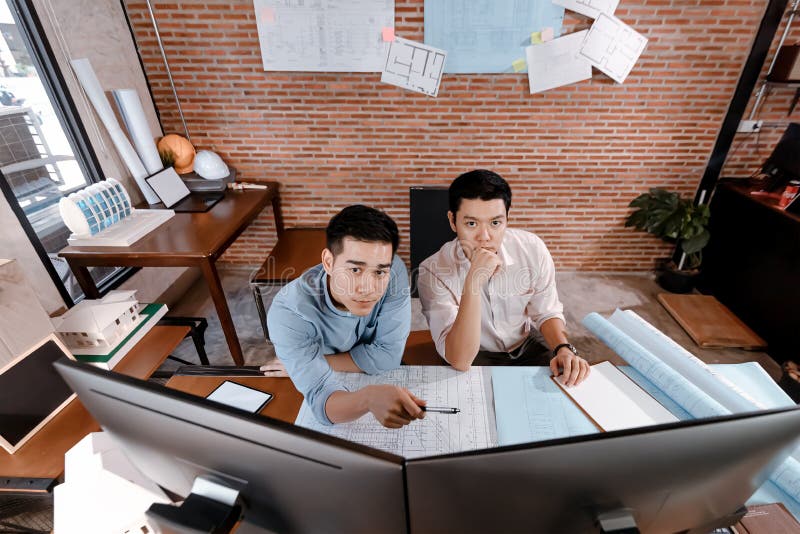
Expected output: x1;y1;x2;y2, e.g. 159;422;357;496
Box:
70;58;159;204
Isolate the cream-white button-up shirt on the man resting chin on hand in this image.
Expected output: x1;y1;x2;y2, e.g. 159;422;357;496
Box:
417;228;564;358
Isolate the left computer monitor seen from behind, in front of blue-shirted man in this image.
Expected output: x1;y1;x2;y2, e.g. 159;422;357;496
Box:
55;359;408;533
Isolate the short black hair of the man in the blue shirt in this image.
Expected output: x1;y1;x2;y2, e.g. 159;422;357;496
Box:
325;204;400;256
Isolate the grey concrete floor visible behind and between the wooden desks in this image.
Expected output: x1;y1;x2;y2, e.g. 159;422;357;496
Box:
162;268;781;380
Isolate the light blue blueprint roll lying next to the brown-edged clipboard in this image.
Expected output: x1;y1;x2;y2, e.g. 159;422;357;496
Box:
583;310;800;512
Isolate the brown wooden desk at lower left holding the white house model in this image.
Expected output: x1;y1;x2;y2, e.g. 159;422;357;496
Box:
0;326;189;478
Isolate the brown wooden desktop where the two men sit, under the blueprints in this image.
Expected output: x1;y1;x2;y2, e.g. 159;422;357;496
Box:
167;330;440;424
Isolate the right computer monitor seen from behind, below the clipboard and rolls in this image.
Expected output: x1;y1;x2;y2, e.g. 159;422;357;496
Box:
406;407;800;534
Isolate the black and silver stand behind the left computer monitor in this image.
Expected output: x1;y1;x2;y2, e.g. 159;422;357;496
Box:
146;475;244;534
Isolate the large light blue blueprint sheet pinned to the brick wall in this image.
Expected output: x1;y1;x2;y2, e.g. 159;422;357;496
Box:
425;0;564;73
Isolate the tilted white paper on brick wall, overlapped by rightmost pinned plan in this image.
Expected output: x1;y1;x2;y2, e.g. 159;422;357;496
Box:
525;30;592;94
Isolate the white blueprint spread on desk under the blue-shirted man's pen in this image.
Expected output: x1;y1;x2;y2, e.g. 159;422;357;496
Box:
295;365;496;458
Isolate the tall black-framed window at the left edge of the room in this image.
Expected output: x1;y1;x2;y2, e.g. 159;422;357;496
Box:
0;0;124;306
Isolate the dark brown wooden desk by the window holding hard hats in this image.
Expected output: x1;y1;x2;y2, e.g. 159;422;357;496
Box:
59;182;282;365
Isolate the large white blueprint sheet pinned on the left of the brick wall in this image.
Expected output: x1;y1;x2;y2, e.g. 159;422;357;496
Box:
253;0;394;72
